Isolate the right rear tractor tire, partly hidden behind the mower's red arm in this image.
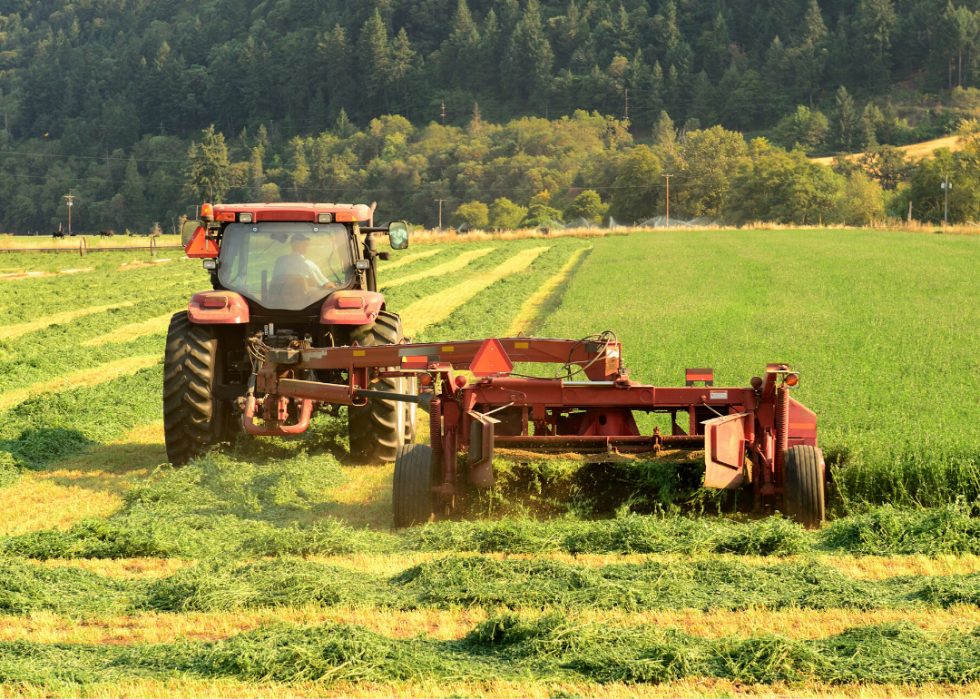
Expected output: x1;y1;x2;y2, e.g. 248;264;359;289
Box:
347;311;415;464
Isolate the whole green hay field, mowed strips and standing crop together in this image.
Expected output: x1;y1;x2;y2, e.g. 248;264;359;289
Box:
0;230;980;697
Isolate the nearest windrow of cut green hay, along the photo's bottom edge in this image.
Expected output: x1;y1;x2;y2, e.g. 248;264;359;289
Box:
0;613;980;693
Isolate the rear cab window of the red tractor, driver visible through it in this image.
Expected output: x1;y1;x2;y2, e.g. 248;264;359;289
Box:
218;221;354;311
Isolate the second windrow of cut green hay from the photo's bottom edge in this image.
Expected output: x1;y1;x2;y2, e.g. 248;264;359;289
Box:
0;555;980;617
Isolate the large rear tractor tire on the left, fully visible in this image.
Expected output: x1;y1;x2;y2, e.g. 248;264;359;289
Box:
163;311;224;466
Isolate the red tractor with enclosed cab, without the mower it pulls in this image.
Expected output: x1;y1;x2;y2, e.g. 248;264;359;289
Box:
163;203;417;465
